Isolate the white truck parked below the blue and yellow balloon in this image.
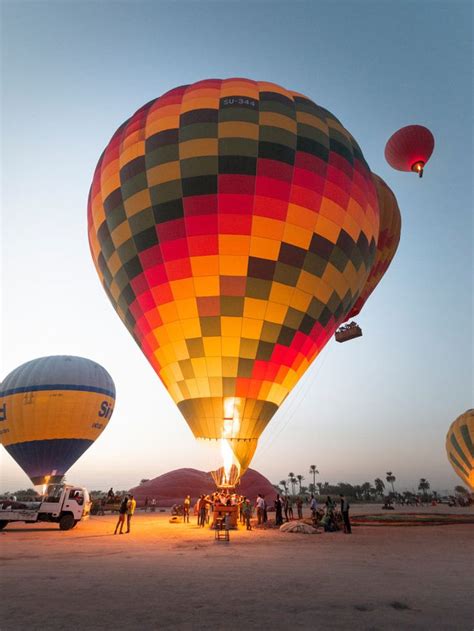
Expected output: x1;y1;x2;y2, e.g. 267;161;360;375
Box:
0;484;92;530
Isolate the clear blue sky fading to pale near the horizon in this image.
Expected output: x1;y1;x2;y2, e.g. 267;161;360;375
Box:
0;0;474;490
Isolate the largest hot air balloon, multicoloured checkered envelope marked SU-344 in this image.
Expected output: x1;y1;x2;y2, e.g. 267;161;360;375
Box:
88;78;386;473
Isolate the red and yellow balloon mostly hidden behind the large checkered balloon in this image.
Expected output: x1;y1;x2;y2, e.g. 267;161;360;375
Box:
347;173;402;318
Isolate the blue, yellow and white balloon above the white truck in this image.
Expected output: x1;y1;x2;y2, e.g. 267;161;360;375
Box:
0;355;115;485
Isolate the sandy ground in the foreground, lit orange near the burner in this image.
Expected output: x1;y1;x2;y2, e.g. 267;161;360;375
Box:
0;506;474;631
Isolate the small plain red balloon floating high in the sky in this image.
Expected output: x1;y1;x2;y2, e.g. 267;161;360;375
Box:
385;125;434;177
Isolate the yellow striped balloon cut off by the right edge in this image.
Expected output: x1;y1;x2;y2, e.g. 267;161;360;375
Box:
446;409;474;490
